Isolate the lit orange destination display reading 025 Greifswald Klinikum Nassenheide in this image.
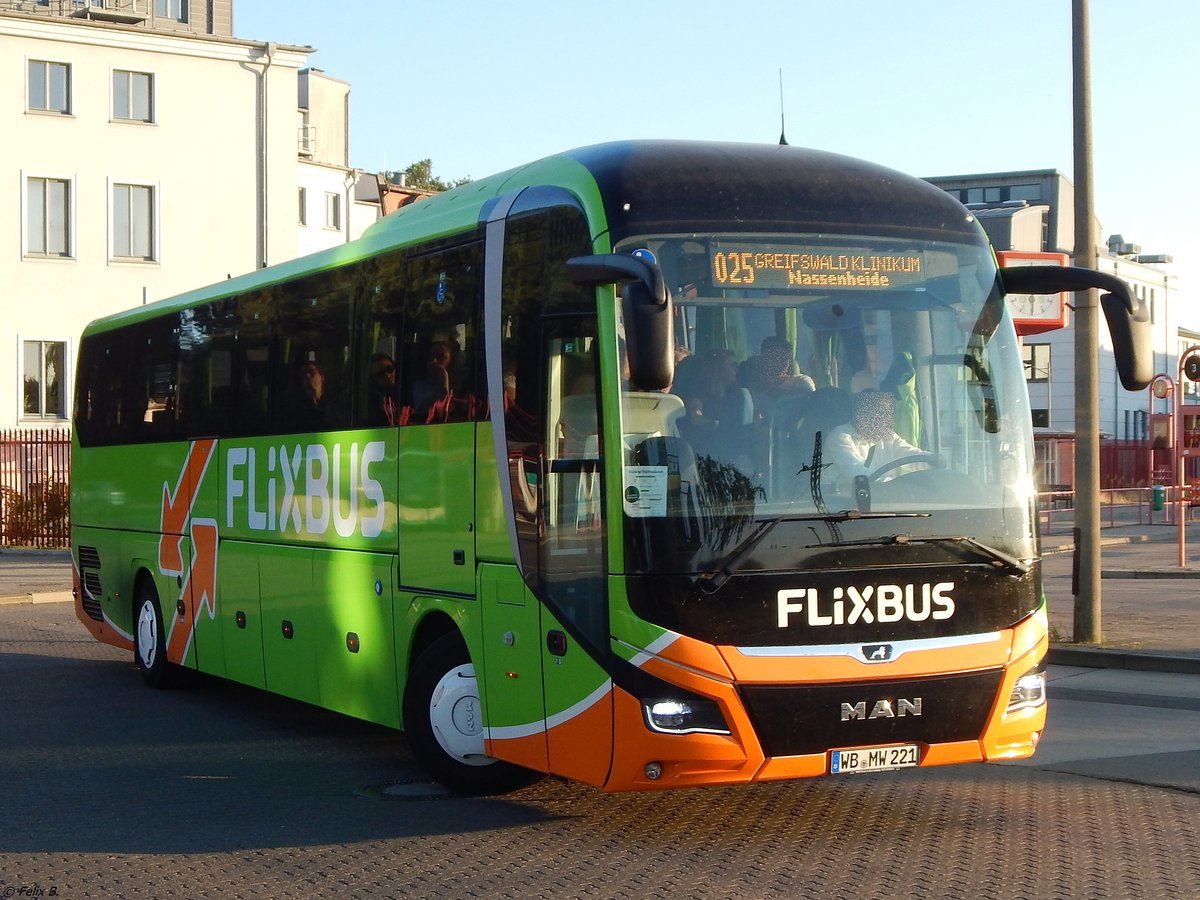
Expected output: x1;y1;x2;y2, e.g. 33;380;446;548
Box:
709;242;925;290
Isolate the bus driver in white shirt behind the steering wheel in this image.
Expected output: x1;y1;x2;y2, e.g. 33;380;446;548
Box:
823;390;944;494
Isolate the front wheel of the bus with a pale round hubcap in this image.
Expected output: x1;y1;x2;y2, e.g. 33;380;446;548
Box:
404;634;542;796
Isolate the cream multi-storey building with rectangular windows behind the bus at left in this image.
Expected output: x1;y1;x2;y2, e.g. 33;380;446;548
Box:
0;0;379;430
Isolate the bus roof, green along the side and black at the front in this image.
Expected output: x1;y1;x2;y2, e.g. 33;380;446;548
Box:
84;140;985;334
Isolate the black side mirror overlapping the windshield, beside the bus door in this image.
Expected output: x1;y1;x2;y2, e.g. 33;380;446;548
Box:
566;253;674;391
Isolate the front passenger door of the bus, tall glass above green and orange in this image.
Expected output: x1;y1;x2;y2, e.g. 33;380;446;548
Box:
484;194;613;785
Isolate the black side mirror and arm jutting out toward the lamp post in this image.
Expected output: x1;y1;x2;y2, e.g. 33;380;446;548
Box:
1000;265;1154;391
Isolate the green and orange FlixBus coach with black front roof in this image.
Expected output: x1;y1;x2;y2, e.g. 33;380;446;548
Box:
71;142;1148;793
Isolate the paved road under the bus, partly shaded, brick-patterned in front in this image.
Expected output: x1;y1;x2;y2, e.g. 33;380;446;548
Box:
0;602;1200;900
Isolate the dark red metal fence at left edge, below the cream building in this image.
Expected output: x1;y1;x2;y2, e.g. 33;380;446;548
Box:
0;428;71;548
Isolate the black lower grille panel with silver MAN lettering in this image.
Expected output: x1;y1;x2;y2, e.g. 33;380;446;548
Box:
739;670;1003;756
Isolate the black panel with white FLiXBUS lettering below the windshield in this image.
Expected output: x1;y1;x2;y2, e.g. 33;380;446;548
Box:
628;564;1040;647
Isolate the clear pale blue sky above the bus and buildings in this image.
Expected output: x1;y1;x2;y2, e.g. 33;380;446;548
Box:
234;0;1200;285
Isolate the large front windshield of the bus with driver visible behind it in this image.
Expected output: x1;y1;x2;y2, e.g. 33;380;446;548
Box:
617;233;1034;578
